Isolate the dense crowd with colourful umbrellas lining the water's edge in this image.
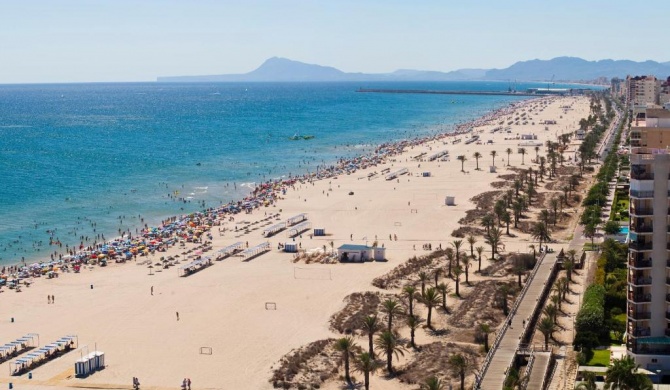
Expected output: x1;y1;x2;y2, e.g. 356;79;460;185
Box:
0;97;548;291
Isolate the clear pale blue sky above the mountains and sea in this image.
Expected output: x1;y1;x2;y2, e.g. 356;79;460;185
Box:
0;0;670;83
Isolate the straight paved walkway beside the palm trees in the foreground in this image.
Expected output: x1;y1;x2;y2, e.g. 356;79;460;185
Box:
480;252;558;390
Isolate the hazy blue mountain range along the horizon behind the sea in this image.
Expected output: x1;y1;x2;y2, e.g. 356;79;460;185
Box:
157;57;670;82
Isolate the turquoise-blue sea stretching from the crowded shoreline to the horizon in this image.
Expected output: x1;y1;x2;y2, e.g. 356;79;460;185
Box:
0;82;596;265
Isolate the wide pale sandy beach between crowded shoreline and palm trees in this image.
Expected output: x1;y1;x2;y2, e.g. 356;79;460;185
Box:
0;97;589;389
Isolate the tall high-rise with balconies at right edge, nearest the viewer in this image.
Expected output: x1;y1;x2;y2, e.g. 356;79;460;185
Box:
626;109;670;371
